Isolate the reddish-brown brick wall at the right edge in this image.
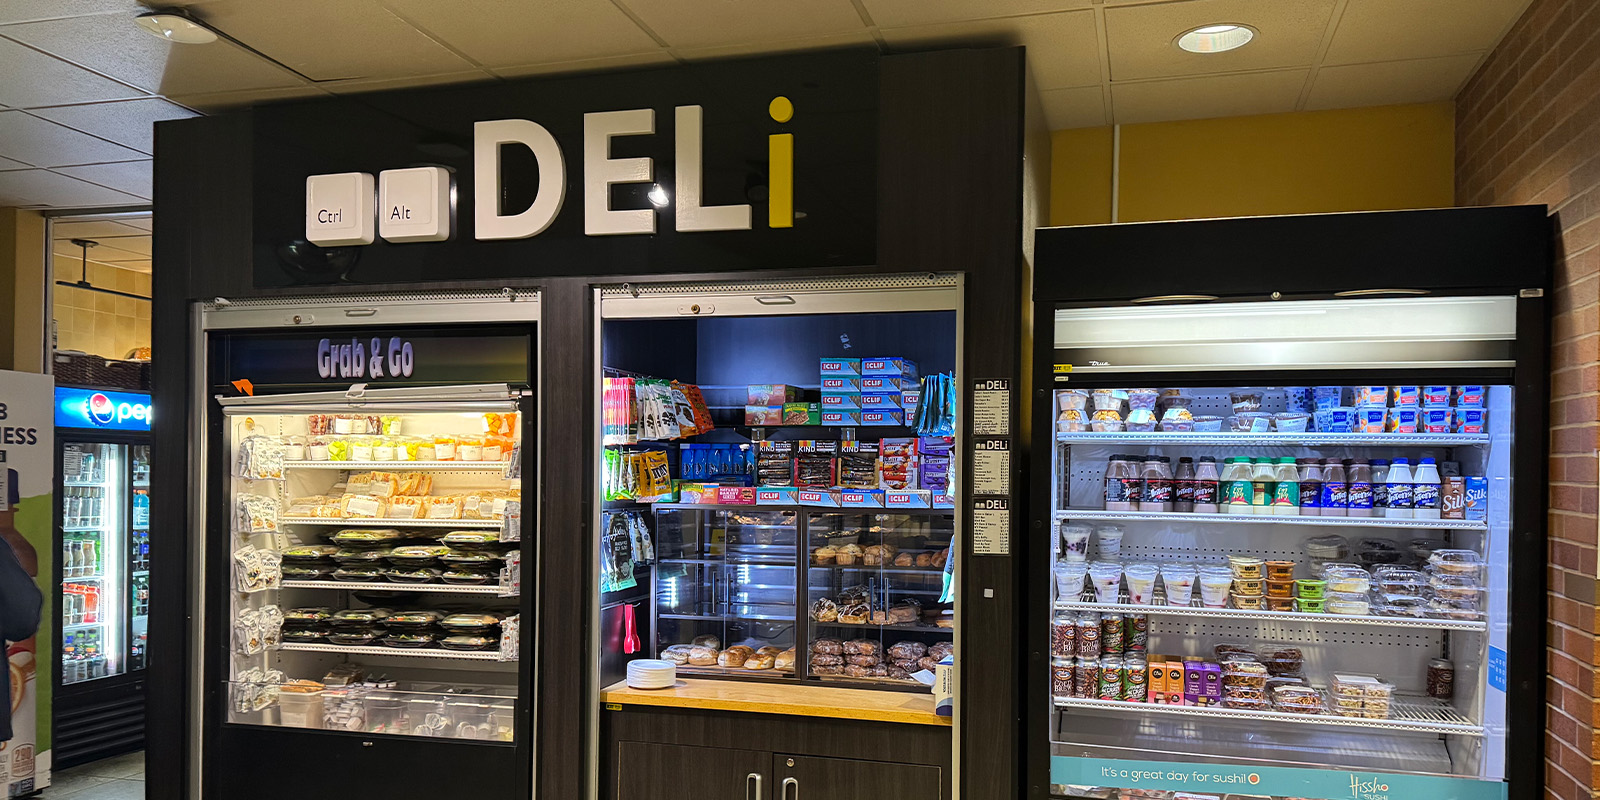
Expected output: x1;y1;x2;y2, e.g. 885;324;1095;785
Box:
1456;0;1600;800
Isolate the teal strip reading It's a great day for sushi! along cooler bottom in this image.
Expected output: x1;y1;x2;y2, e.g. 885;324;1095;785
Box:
1050;755;1506;800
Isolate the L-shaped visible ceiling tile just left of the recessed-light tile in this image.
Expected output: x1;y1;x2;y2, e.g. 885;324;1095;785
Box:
880;11;1101;91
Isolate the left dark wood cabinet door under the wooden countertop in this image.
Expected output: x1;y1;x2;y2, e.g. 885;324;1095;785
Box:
614;742;771;800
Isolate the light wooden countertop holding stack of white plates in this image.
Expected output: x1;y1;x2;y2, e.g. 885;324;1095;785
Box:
600;678;950;725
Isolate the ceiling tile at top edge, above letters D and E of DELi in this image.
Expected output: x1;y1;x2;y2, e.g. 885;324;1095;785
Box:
384;0;659;70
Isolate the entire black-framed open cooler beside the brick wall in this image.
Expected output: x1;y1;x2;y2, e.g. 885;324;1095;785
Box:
1026;210;1549;800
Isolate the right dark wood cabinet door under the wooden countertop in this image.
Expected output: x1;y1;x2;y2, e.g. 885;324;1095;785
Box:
771;754;942;800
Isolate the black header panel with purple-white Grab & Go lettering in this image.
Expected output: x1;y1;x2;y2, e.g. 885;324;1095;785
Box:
211;326;533;397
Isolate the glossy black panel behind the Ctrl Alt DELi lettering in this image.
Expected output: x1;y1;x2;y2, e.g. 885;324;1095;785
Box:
253;53;876;288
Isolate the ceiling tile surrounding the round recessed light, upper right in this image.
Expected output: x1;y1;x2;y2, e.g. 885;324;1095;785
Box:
1106;0;1334;80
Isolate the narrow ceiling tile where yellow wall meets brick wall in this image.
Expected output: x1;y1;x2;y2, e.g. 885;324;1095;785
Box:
1306;53;1483;110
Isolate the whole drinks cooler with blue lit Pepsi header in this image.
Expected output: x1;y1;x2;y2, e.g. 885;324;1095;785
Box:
54;386;150;768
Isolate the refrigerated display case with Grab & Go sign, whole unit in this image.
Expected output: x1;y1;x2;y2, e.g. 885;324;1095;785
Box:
194;293;538;798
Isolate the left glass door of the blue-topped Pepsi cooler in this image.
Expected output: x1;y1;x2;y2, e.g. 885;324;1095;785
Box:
61;442;130;685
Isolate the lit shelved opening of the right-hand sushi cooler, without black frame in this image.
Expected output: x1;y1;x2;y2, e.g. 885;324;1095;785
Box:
1035;298;1516;800
